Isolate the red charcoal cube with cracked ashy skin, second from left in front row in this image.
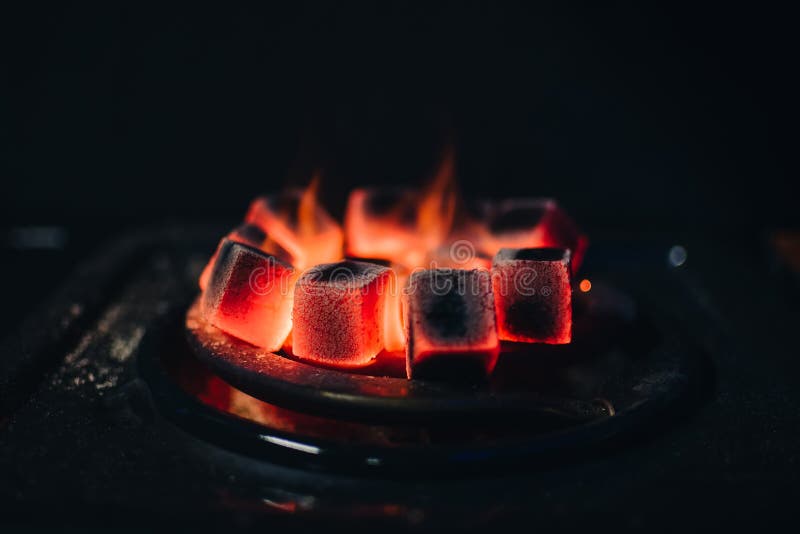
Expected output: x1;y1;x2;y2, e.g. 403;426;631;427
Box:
292;261;392;367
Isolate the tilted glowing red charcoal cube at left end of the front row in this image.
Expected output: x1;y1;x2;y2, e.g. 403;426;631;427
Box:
203;239;295;351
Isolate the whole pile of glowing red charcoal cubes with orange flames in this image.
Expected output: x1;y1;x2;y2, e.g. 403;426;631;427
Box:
199;150;588;378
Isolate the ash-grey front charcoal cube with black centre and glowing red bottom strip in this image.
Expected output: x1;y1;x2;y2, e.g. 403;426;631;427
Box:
405;269;500;381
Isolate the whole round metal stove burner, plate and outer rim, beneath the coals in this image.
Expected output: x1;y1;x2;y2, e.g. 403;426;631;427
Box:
134;281;700;474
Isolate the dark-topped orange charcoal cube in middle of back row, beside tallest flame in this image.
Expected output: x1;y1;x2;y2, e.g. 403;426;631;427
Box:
345;187;419;259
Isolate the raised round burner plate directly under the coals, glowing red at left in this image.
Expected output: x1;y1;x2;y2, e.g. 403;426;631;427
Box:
186;280;693;424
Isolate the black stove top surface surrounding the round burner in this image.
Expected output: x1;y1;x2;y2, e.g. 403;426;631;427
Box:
0;226;800;530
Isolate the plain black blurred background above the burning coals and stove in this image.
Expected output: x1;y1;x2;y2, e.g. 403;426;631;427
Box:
0;2;798;232
